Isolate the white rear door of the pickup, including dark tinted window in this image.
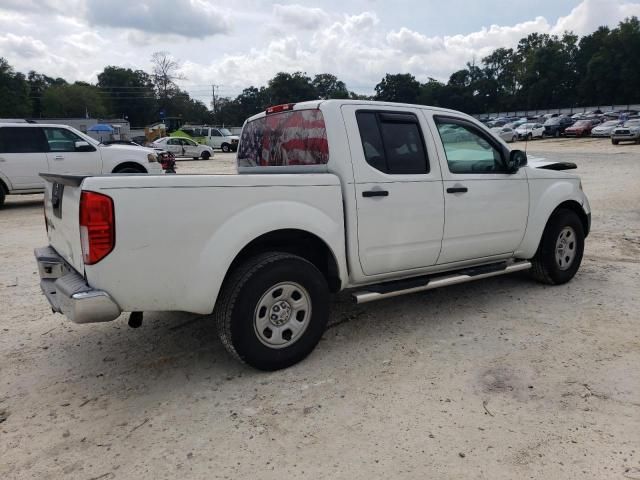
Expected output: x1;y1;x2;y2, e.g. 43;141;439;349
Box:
342;105;444;275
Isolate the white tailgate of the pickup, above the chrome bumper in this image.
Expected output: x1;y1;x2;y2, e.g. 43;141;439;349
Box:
40;174;87;274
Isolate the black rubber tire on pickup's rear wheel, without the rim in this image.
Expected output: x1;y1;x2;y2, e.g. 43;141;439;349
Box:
214;252;329;371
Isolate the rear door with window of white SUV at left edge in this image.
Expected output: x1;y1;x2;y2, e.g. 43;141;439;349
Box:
0;126;49;190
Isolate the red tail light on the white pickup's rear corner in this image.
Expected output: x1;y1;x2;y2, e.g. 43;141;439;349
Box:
80;192;116;265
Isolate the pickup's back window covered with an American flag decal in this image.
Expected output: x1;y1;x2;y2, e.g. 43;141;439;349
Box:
238;110;329;167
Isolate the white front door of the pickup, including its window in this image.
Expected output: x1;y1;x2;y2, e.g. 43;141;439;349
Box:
432;115;529;264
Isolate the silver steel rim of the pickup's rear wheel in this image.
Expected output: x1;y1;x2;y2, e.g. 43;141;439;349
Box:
253;282;311;348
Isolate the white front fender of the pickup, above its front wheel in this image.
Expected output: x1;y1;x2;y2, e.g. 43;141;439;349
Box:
514;175;591;258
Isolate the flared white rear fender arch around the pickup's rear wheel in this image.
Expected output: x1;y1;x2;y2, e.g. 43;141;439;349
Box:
185;201;348;313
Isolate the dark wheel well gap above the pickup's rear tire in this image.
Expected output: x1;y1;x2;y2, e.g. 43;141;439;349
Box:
225;229;341;292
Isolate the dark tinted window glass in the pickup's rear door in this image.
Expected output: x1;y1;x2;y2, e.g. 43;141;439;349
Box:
356;111;429;175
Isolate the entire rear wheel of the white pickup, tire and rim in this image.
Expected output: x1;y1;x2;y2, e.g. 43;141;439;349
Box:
214;252;329;371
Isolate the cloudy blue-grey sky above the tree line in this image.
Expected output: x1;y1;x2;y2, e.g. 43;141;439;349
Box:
0;0;640;103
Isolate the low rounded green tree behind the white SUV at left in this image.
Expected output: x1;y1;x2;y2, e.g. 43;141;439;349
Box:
42;82;107;118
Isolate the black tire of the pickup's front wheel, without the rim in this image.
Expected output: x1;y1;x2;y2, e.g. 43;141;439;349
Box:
531;209;584;285
